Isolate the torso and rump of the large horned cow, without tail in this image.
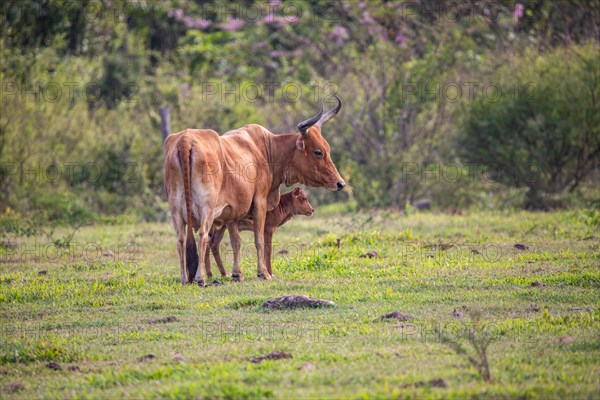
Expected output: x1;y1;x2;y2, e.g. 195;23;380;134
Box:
165;124;272;230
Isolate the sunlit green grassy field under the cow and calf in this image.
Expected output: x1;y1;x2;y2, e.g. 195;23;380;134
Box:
0;209;600;398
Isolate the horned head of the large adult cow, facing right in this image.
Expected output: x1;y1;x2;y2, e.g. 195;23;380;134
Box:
293;96;346;191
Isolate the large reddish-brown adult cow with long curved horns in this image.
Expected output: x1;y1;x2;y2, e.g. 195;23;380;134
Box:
164;96;345;286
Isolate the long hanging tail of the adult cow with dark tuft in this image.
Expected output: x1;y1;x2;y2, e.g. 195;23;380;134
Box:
177;136;199;283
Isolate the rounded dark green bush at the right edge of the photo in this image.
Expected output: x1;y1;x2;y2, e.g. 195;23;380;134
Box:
461;44;600;209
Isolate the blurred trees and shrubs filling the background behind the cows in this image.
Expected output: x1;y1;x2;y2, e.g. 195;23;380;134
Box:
0;0;600;220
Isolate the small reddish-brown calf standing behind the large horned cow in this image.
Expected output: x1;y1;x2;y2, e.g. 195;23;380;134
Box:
205;187;315;278
